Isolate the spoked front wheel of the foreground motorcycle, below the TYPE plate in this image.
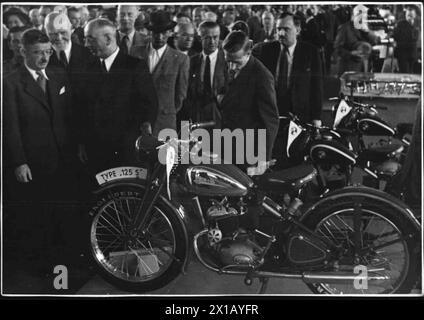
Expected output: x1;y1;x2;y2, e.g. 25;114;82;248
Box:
90;188;186;292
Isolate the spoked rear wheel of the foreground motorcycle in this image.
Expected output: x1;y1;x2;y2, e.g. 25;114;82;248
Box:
305;199;419;294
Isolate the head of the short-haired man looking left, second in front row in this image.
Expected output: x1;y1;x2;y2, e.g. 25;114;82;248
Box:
84;19;118;59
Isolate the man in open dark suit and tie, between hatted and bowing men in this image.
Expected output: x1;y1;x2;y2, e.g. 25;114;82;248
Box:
180;21;228;128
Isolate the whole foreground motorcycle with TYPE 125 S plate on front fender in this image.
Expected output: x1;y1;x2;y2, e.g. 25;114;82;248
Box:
89;123;421;294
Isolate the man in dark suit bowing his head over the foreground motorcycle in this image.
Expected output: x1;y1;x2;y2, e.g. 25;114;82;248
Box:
221;31;279;165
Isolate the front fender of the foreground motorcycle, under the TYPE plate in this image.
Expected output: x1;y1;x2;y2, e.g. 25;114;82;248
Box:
90;179;193;272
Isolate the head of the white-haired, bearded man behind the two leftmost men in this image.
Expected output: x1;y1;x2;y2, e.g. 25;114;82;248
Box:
44;12;72;51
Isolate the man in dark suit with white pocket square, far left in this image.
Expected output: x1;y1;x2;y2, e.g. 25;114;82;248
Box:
3;29;75;272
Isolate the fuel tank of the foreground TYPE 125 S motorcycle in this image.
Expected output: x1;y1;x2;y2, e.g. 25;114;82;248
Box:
185;164;253;197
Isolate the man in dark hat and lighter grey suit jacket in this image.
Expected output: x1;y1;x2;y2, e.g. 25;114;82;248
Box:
138;10;190;136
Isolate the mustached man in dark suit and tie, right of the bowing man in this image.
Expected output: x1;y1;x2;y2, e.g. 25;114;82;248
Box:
253;13;323;165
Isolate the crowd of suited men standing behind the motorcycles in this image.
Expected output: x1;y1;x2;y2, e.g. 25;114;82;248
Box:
3;5;418;278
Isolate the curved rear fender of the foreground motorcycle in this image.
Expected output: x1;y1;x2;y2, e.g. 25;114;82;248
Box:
300;186;421;233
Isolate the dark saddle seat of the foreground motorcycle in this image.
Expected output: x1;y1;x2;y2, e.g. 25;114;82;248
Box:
257;164;317;193
